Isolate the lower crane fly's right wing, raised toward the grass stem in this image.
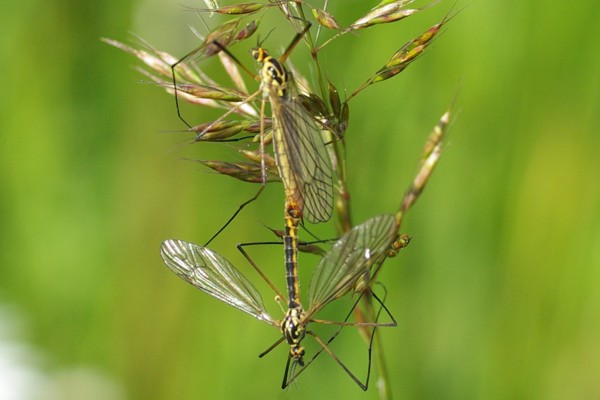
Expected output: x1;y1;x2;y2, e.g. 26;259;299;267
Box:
307;215;396;314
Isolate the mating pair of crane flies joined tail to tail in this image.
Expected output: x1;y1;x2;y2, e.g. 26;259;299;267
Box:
161;14;397;390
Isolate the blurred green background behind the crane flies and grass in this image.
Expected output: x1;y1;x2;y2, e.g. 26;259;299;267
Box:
0;0;600;399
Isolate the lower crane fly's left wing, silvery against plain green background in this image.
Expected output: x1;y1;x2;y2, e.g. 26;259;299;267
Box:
160;239;276;325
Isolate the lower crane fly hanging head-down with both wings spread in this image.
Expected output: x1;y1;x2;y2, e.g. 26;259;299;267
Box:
161;215;397;390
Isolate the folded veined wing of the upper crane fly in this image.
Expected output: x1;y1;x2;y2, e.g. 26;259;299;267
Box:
271;91;333;223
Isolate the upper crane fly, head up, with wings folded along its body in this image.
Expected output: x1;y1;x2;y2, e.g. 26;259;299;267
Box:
171;23;333;245
